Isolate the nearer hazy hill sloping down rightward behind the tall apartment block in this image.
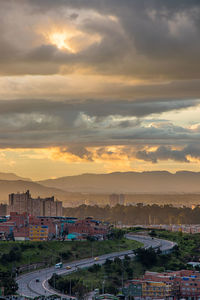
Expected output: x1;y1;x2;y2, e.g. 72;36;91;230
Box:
0;180;74;203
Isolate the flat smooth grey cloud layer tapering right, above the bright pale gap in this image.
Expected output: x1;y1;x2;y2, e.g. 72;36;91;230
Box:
0;99;200;117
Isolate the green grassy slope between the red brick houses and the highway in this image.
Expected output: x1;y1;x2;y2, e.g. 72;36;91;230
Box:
0;238;141;271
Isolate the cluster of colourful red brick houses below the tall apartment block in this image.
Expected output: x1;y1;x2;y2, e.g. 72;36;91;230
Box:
0;210;110;241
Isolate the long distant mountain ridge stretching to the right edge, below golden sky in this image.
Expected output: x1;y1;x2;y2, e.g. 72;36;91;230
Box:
39;171;200;194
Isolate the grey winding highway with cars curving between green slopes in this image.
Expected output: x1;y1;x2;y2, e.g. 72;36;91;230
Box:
16;234;176;298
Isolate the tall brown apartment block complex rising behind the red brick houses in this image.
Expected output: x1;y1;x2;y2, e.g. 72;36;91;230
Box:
8;190;62;217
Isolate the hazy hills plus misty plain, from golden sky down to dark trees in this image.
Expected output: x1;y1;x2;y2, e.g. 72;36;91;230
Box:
0;171;200;207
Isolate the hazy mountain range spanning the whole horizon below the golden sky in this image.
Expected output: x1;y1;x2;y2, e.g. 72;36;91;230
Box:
0;171;200;202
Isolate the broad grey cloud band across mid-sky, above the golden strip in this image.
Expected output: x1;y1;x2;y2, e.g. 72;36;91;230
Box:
0;100;199;149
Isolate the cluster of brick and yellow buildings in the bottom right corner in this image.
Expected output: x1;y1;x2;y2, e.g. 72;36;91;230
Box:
123;270;200;300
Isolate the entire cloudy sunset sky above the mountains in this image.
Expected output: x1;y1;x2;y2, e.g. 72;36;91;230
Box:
0;0;200;180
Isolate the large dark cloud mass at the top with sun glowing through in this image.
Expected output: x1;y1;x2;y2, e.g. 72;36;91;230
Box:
0;0;200;80
